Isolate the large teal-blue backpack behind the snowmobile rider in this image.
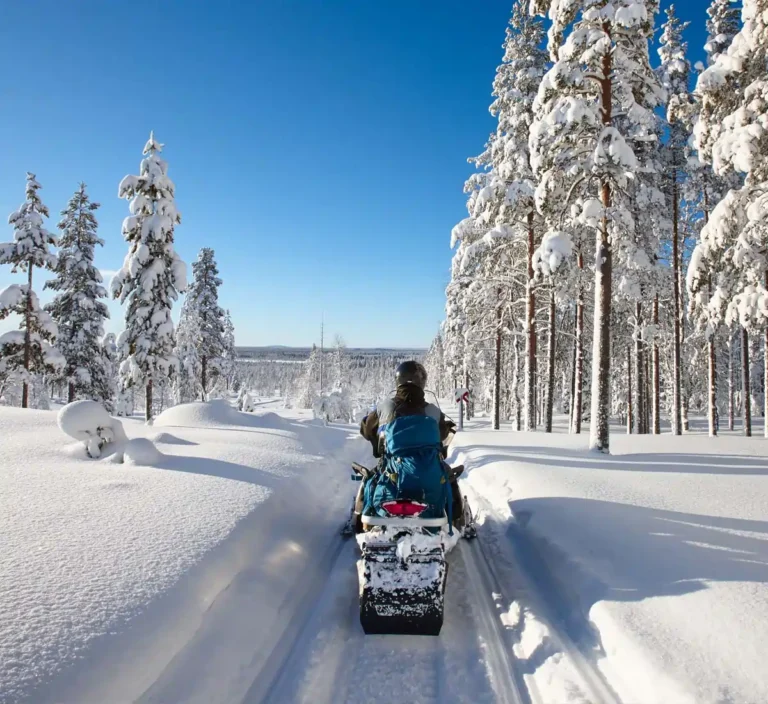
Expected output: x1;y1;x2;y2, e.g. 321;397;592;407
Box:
364;415;452;525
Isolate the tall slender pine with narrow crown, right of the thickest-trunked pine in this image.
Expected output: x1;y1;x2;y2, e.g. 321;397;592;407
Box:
659;5;691;435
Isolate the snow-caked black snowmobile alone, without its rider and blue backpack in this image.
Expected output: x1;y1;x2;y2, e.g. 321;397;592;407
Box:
351;446;476;636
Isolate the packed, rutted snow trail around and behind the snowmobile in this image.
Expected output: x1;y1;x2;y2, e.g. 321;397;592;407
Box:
237;537;617;704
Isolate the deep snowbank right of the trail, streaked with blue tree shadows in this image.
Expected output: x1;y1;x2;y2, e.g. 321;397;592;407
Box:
454;420;768;704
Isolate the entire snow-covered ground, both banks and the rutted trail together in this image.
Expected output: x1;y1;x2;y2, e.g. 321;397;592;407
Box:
0;401;768;704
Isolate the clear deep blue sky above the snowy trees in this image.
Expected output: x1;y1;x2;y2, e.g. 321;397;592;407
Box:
0;0;707;346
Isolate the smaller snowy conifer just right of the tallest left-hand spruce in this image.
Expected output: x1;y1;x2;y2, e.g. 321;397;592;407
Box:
186;247;224;401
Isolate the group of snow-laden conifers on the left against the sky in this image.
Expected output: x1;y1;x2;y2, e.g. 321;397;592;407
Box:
0;135;236;420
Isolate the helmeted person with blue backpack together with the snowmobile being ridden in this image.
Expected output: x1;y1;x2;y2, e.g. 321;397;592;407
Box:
353;362;474;635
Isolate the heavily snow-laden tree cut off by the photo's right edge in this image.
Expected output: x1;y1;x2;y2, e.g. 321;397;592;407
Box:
691;0;768;434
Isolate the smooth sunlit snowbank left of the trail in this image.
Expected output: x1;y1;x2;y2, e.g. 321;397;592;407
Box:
0;402;358;704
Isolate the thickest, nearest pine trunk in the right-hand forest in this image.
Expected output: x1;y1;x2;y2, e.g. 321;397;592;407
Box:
589;31;613;452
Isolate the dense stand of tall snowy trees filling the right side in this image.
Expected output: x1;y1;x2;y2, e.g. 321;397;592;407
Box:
427;0;768;451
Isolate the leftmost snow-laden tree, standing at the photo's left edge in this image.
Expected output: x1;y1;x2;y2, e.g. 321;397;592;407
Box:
0;173;61;408
